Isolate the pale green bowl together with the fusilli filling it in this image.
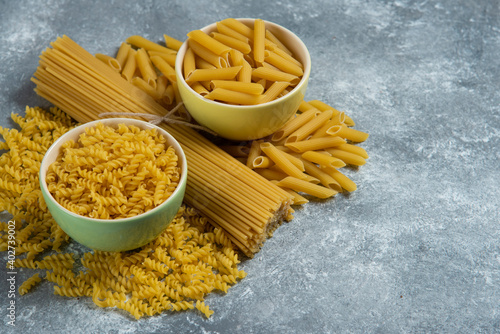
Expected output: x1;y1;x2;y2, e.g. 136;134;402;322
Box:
39;118;187;252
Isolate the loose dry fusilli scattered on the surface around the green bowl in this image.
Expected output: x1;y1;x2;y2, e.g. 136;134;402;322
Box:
0;108;246;319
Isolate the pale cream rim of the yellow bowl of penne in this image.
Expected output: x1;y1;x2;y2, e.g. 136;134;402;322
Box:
175;18;311;110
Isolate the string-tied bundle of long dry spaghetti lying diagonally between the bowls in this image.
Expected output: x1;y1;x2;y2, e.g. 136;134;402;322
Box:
32;36;293;257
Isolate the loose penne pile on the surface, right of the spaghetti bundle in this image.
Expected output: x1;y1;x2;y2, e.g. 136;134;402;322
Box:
222;100;368;205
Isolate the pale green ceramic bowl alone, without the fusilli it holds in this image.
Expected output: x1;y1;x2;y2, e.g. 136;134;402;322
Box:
39;118;188;252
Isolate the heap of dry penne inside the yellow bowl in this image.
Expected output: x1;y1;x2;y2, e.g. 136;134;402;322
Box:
183;18;304;105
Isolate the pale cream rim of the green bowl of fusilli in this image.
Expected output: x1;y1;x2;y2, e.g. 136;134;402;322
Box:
38;117;188;224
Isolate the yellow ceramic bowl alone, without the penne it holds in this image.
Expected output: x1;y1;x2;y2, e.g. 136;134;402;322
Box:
175;19;311;140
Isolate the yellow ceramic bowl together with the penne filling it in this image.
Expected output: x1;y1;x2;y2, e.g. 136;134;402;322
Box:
175;18;311;140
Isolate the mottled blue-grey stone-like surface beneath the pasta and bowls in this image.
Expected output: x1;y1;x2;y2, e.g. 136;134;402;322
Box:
0;0;500;334
